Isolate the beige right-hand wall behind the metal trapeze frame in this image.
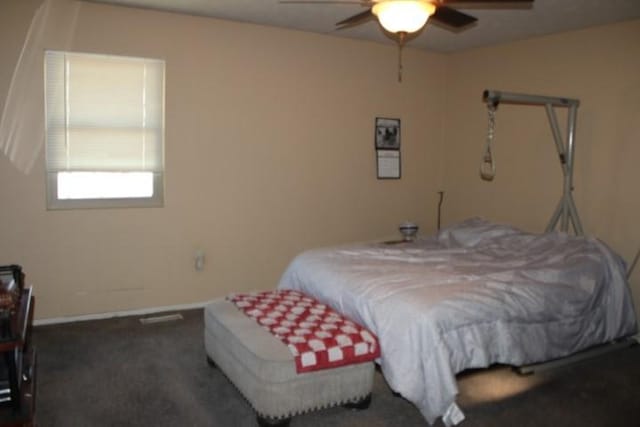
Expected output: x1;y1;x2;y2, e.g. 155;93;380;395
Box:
443;20;640;320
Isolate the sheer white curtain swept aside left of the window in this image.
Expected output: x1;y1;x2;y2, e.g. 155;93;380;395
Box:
0;0;80;174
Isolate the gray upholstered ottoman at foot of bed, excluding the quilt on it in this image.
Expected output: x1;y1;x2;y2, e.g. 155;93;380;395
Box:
204;299;374;426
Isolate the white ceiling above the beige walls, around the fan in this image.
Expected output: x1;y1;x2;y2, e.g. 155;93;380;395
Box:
90;0;640;52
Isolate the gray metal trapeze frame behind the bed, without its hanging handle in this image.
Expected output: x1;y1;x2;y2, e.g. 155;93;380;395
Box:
483;90;584;236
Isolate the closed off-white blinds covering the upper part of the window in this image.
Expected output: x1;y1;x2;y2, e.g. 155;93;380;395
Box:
45;51;164;174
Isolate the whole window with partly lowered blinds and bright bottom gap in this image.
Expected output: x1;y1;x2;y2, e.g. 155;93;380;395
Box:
45;51;164;209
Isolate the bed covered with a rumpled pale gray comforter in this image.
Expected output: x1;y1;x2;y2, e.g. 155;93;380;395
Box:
278;218;637;425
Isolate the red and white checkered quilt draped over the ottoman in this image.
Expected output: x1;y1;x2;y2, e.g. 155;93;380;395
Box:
227;290;380;373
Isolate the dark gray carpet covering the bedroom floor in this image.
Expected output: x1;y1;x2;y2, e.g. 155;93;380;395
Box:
33;310;640;427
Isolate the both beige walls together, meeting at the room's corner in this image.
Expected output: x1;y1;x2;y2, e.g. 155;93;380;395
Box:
0;0;640;319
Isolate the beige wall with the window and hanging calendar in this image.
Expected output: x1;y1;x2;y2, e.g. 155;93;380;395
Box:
0;0;446;319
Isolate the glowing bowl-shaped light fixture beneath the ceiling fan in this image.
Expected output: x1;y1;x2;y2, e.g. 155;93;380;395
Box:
371;0;436;33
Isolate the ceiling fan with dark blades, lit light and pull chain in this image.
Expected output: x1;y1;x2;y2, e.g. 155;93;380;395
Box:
280;0;534;81
